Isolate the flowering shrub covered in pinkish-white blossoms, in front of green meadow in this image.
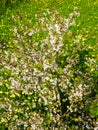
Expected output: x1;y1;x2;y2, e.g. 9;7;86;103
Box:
0;7;98;130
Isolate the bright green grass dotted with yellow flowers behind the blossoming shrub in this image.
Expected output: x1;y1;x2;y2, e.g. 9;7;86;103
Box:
0;0;98;45
